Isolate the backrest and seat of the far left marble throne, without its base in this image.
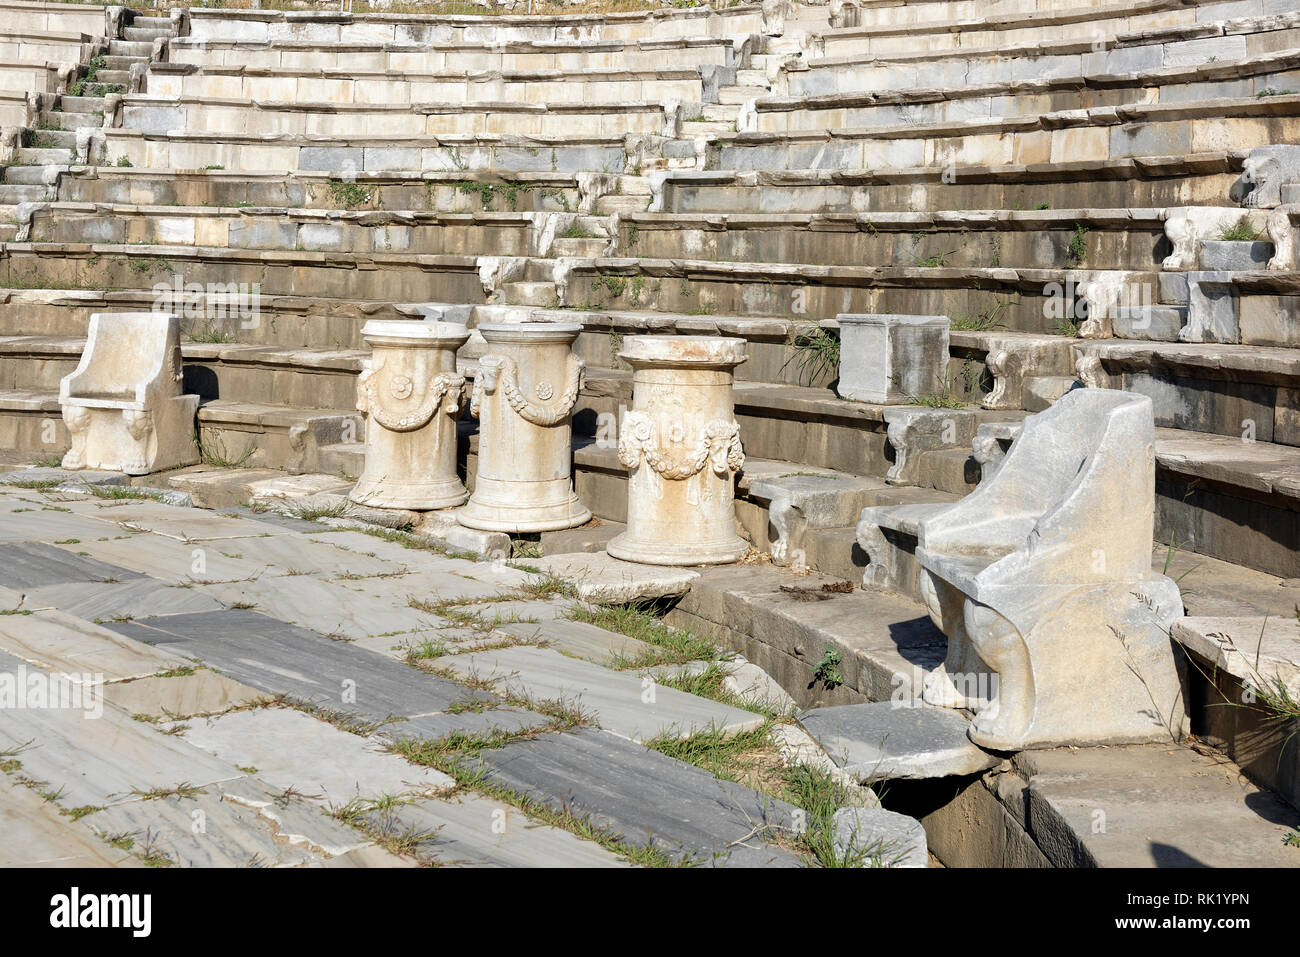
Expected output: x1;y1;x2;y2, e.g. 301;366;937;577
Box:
59;312;181;411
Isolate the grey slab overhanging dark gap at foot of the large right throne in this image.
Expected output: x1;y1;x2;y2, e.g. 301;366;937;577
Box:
800;701;1001;781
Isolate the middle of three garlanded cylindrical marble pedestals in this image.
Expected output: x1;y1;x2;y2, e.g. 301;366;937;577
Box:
456;322;592;532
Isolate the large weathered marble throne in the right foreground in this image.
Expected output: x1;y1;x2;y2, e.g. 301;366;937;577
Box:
917;390;1183;750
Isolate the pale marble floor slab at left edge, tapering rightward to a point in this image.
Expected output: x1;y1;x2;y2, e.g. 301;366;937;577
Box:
0;610;190;681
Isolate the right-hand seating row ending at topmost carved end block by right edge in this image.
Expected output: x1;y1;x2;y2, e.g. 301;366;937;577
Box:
653;151;1245;215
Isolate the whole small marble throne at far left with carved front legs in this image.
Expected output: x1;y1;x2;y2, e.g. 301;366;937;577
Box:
59;312;199;475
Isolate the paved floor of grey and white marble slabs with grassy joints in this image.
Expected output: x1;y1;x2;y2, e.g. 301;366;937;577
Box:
0;486;832;867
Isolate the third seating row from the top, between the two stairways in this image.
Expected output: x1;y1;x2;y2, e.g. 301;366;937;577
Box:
140;62;716;105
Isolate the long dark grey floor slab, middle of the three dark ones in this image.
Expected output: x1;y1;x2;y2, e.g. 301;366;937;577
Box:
105;610;491;720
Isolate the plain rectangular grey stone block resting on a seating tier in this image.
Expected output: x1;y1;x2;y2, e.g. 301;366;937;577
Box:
839;315;948;404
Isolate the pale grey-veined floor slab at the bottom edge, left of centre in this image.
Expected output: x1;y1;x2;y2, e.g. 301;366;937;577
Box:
78;787;369;867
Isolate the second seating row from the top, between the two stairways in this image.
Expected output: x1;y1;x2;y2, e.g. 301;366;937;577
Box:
166;36;751;73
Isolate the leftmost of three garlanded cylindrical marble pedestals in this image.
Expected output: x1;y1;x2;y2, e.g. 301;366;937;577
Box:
348;320;469;511
